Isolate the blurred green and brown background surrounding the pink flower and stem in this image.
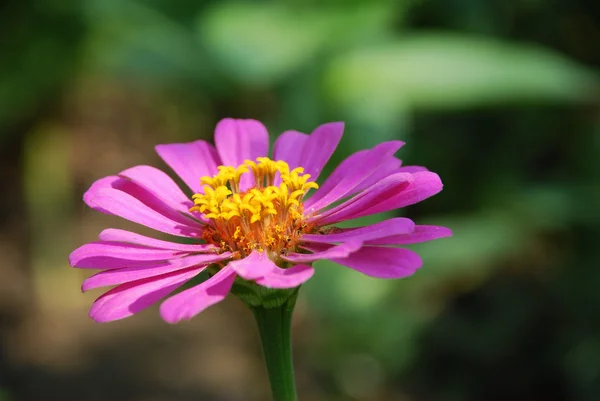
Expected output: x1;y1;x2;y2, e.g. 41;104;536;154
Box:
0;0;600;401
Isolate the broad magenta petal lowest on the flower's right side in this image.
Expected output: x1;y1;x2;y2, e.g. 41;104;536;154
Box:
306;244;423;278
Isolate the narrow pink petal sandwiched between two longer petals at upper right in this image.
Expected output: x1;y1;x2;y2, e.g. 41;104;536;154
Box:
308;173;413;226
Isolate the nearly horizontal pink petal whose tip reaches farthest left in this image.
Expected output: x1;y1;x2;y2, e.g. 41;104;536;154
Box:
69;242;182;269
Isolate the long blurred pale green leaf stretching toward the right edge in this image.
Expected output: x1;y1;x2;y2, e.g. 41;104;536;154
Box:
324;33;598;115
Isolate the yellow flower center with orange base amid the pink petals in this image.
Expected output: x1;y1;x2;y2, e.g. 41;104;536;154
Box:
190;157;318;260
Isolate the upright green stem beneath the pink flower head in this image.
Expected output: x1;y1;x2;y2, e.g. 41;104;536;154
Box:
251;293;297;401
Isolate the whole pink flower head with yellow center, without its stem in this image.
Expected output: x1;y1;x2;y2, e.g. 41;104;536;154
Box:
69;119;451;323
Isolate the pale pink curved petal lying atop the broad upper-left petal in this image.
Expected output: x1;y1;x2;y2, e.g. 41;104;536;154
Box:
119;166;193;214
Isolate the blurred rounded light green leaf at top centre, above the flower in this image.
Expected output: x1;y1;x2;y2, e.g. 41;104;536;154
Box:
198;2;393;84
